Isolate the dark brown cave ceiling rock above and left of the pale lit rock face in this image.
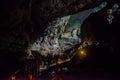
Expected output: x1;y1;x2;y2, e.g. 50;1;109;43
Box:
0;0;99;50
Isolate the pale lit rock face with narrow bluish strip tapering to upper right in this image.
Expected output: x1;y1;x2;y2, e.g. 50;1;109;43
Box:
32;2;107;55
